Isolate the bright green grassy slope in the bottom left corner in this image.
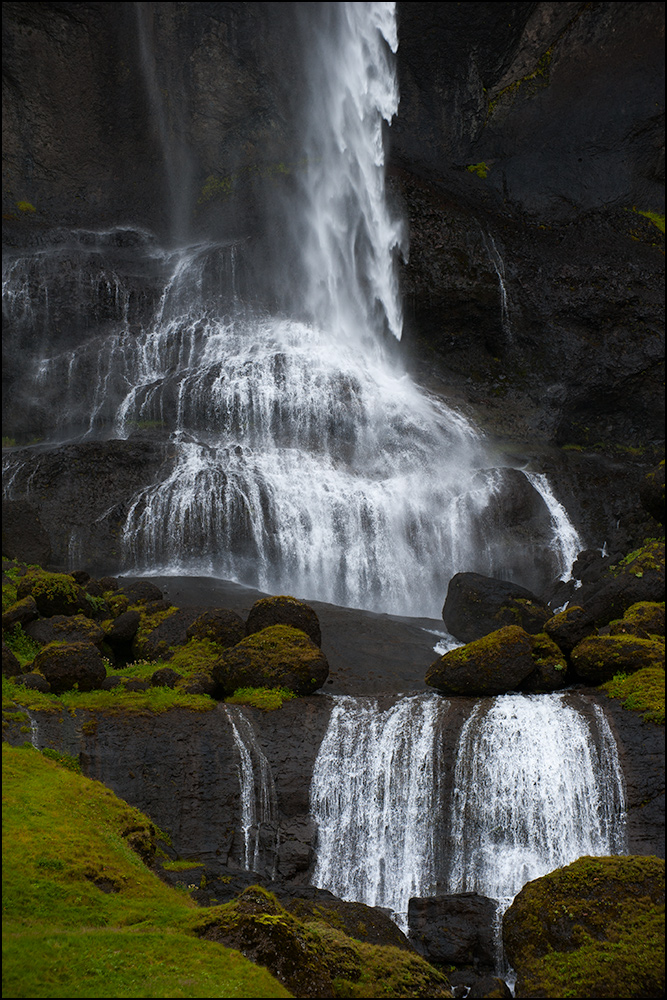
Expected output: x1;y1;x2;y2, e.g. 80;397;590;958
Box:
2;744;290;997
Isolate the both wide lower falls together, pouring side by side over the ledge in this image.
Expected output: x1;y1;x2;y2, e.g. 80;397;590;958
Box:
310;693;627;929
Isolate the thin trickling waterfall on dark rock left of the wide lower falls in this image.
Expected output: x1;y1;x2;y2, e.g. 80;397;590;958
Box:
225;705;278;878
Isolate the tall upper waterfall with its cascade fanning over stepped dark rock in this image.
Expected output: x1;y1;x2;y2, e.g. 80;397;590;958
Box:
3;3;576;617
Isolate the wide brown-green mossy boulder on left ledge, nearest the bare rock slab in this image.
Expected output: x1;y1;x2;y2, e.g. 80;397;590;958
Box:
212;625;329;697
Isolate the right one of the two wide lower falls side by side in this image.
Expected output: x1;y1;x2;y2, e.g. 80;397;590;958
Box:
449;694;627;912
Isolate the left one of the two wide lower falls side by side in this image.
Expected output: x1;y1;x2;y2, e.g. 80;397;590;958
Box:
310;695;448;927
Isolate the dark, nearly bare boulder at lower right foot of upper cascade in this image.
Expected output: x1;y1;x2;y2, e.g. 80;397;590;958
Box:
442;573;551;642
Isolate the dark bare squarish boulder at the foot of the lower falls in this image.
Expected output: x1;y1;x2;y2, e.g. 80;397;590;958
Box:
408;892;496;968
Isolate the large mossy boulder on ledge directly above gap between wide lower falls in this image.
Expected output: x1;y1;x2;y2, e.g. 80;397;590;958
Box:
425;625;535;696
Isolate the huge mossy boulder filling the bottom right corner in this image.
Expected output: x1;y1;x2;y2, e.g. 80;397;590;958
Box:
503;856;665;997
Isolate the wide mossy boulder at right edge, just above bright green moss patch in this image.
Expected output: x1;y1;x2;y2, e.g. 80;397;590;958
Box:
570;635;665;684
